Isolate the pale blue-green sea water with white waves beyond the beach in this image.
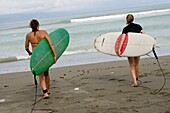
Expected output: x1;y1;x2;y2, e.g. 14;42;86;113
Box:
0;5;170;74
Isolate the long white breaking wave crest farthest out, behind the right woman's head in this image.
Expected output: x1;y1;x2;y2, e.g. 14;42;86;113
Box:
70;9;170;23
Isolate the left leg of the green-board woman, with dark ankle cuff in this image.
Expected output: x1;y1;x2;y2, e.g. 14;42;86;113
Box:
39;73;49;98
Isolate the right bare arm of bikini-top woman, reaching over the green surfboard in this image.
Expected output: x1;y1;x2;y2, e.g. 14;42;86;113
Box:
45;31;57;63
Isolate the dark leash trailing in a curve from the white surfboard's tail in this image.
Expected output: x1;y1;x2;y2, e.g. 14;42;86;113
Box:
151;47;166;95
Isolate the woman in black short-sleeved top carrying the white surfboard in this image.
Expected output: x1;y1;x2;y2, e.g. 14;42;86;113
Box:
118;14;144;87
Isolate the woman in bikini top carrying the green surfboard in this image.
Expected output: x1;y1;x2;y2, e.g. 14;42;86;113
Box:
25;19;57;99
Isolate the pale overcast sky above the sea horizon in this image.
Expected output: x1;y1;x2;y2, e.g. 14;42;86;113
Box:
0;0;170;15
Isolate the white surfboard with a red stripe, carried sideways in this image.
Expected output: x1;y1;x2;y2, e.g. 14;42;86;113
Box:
94;32;156;57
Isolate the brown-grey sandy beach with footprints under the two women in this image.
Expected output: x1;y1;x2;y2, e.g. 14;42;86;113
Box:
0;56;170;113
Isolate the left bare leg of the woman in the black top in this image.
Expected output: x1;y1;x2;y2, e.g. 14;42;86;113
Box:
128;57;138;86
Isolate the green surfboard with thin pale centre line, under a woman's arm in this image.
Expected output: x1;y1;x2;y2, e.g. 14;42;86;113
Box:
30;28;69;75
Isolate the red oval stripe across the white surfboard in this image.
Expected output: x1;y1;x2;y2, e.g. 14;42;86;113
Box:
115;34;128;56
